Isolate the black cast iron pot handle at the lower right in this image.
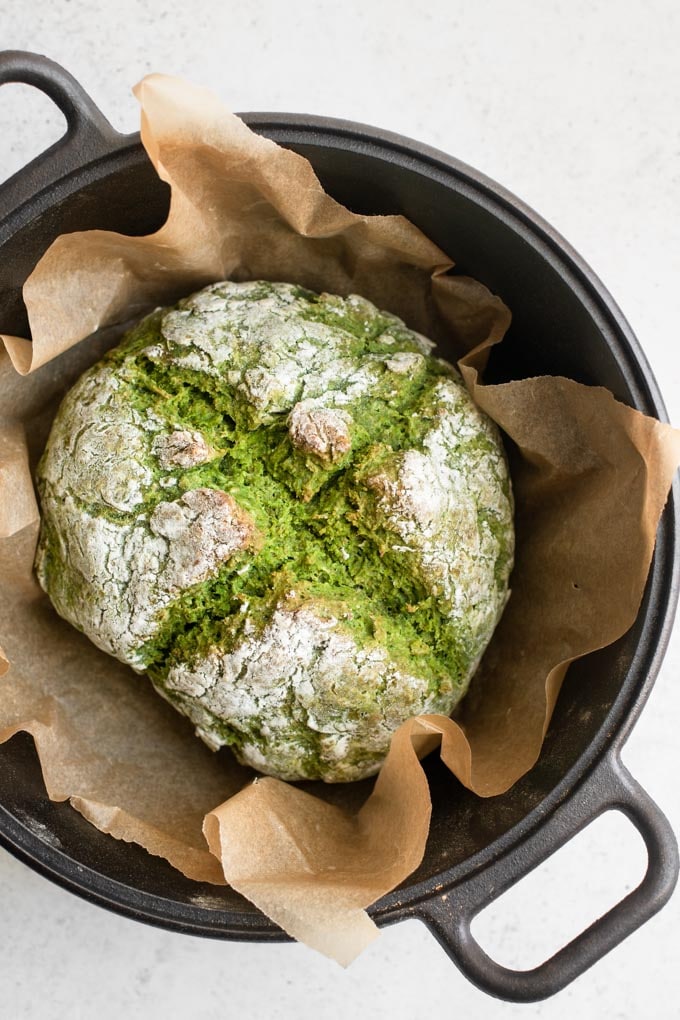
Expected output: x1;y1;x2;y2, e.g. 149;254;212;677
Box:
418;752;678;1002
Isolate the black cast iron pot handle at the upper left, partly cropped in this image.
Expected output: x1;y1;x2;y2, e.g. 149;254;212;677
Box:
0;50;125;210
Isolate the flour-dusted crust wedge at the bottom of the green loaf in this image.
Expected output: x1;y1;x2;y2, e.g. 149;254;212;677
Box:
165;603;435;781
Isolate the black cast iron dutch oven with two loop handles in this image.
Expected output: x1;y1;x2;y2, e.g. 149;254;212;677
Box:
0;52;679;1002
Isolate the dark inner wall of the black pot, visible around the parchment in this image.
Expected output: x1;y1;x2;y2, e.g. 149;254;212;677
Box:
0;139;653;930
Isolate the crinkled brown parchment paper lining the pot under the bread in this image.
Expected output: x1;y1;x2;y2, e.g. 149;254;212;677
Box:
0;74;680;963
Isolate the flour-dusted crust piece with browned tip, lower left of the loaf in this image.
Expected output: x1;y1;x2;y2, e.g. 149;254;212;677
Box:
37;489;257;670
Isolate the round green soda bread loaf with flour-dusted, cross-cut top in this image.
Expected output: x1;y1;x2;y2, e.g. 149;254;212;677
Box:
36;283;514;782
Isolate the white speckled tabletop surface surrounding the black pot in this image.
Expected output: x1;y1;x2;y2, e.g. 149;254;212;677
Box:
0;0;680;1020
